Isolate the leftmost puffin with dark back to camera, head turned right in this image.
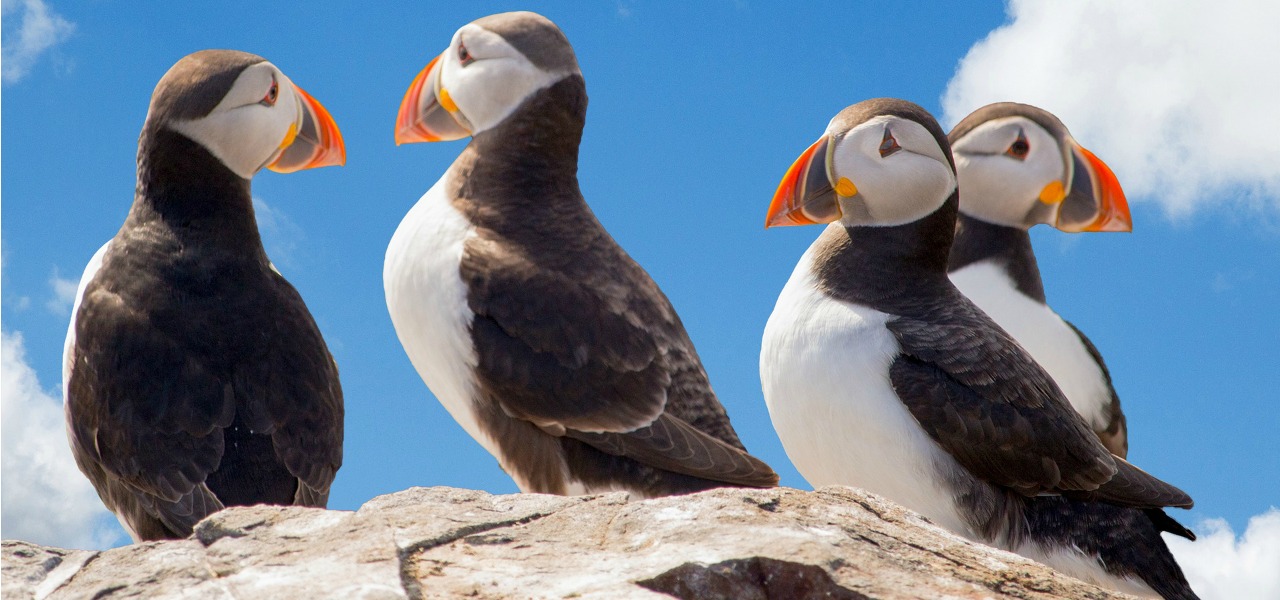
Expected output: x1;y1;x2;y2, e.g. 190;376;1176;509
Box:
63;50;346;541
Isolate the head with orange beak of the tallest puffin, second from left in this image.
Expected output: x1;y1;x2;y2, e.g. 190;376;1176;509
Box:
396;12;581;145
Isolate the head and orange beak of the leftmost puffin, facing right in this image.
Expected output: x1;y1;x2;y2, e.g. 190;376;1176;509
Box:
154;50;347;179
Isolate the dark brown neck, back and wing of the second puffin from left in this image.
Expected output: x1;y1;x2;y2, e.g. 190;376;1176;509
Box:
449;69;777;495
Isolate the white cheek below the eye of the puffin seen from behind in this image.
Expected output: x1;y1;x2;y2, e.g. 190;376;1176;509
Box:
173;102;288;179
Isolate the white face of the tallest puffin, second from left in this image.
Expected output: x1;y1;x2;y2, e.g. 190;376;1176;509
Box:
440;23;572;136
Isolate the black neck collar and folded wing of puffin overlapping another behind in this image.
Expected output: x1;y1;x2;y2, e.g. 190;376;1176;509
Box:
817;212;1190;508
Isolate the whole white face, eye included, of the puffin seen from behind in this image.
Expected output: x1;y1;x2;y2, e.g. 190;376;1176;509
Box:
170;61;302;179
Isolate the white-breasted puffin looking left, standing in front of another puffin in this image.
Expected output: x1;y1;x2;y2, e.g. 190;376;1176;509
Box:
760;99;1194;599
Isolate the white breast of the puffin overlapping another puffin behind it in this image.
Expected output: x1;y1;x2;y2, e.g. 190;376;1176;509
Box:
760;248;974;537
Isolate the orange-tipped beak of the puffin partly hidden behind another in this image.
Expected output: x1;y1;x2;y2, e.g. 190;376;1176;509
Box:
1053;141;1133;233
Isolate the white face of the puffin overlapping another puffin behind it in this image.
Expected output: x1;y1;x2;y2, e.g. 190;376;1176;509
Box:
814;115;956;226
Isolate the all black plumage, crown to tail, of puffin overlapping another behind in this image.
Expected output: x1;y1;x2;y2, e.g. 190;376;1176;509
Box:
783;100;1196;599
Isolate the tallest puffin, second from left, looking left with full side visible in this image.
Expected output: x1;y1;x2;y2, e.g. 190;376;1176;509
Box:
383;12;778;498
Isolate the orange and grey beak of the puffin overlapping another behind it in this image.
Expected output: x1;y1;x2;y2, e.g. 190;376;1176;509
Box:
764;136;858;229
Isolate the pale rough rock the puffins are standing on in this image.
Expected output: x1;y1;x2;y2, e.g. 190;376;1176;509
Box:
3;487;1128;600
